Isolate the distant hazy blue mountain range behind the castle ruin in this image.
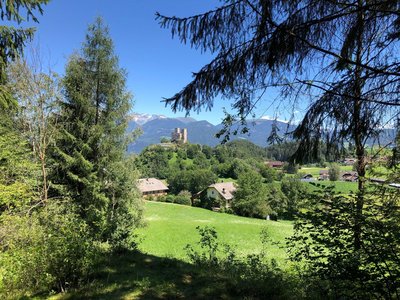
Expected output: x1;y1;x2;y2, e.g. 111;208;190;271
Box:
128;114;294;153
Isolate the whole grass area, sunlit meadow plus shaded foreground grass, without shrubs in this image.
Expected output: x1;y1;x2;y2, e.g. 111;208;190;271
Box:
49;202;292;300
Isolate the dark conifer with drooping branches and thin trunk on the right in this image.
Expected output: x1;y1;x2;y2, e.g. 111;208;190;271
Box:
157;0;400;294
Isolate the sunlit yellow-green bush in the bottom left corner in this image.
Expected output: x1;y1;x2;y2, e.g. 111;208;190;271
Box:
0;202;99;297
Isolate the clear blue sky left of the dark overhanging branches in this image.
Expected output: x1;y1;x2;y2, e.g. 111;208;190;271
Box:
25;0;294;124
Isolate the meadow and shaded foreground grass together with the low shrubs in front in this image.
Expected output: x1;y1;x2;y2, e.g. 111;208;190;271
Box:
50;202;298;299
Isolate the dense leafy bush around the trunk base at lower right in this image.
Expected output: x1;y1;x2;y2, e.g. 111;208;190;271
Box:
289;187;400;299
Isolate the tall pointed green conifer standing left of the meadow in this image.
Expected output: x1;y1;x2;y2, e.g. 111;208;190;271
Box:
54;18;140;245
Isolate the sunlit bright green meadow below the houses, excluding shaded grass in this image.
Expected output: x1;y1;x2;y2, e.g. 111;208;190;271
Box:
138;202;292;262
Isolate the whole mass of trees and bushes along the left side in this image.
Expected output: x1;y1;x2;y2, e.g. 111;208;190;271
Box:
0;17;142;298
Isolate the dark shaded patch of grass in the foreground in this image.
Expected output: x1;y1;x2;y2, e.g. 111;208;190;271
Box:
56;252;235;300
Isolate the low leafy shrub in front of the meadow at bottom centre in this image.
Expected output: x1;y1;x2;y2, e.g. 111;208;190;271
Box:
186;226;302;299
